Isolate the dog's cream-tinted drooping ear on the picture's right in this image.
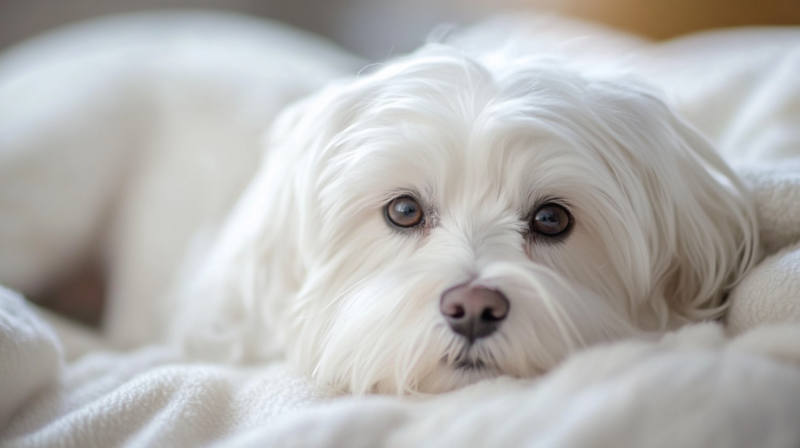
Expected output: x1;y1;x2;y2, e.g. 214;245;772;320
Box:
608;87;759;329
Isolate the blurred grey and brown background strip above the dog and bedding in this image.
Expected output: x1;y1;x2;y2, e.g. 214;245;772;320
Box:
0;0;800;60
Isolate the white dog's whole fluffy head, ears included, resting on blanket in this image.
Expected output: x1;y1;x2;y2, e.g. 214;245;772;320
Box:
180;47;755;393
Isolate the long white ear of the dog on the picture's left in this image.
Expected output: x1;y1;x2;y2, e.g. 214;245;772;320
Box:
171;82;366;362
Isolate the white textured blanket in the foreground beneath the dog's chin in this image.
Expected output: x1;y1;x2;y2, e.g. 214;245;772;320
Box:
0;292;800;447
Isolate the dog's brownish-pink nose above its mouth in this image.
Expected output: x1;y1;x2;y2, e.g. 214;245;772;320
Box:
439;285;509;342
